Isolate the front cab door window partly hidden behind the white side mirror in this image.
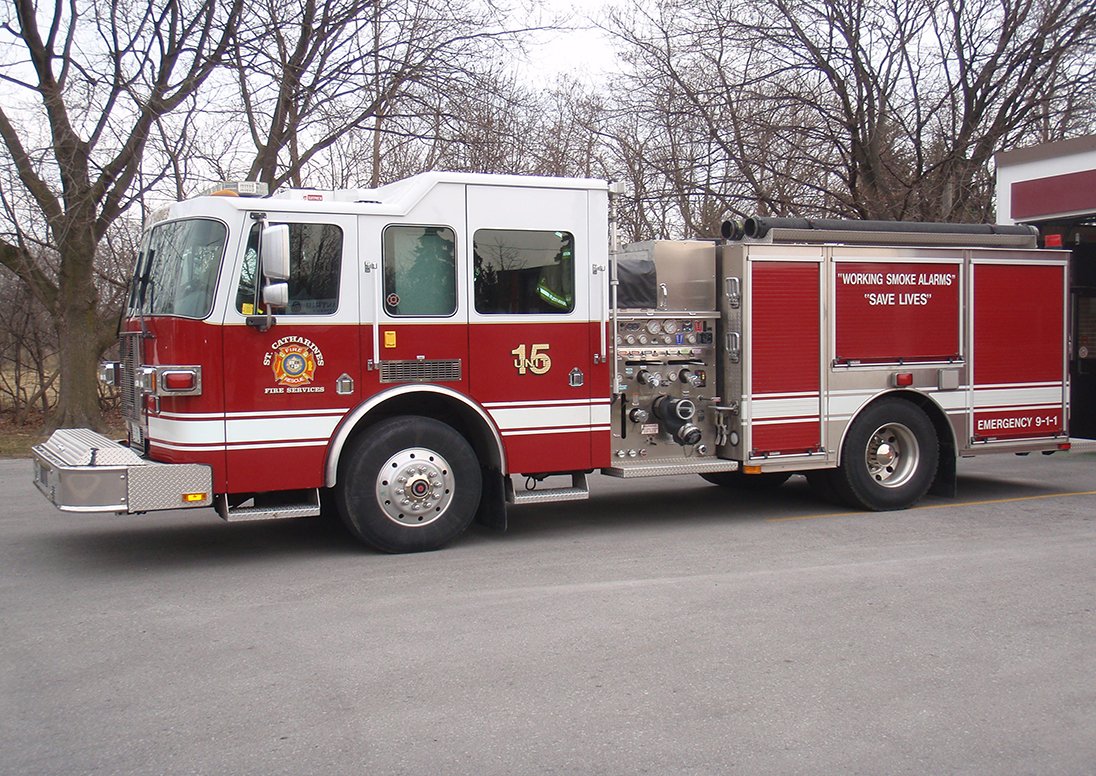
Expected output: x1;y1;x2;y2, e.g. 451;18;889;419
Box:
236;224;343;316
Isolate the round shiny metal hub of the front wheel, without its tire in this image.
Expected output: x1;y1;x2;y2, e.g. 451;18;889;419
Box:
376;447;456;526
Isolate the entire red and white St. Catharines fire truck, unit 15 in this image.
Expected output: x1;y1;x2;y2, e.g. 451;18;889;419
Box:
34;173;1070;551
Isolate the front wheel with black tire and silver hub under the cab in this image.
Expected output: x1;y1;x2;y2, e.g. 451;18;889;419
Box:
335;416;483;552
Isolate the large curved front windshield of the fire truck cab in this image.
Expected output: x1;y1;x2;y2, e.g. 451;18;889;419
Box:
129;218;227;318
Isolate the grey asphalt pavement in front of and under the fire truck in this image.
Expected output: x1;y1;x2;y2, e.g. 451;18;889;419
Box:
0;454;1096;776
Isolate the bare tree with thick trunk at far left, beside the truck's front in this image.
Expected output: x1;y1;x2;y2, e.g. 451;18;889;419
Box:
0;0;243;426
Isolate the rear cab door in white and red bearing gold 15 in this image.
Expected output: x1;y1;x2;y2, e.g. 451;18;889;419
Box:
467;185;607;473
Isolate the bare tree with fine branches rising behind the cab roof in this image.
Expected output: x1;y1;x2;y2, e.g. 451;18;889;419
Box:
221;0;543;189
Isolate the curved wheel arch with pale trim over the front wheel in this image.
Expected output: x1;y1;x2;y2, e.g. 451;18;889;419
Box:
323;385;506;488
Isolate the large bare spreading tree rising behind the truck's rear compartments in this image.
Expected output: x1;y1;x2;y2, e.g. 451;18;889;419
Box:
612;0;1096;226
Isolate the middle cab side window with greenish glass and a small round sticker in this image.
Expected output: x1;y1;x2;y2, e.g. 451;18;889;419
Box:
384;226;457;317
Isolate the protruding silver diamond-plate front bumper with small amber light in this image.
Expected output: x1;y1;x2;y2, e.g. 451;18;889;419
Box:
33;429;213;514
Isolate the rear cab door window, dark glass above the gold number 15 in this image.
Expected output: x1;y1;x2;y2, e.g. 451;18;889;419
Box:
472;229;574;315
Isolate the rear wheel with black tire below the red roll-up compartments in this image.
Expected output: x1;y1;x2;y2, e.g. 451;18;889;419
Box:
829;399;940;512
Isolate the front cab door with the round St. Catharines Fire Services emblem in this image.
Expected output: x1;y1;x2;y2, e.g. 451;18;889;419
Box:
224;213;362;493
